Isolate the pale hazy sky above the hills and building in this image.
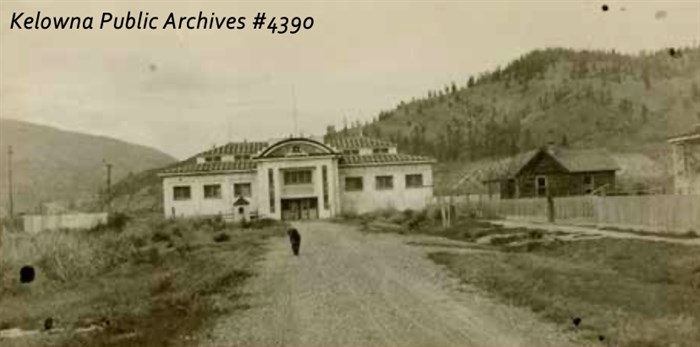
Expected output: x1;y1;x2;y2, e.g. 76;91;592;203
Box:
0;0;700;158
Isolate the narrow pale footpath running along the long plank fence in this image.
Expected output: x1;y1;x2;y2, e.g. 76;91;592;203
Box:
491;220;700;246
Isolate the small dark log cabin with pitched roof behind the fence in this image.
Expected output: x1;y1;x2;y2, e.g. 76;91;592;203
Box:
484;145;619;199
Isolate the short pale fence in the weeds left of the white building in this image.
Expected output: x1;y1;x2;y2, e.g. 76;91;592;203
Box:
22;212;107;233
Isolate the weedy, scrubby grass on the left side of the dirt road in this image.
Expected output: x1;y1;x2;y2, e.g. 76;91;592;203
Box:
0;217;284;346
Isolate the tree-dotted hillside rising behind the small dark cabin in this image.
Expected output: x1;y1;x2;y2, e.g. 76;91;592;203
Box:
356;48;700;162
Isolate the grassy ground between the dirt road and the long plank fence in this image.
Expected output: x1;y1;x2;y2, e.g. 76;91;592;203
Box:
342;215;700;347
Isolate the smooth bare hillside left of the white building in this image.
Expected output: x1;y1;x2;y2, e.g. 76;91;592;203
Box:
0;119;175;214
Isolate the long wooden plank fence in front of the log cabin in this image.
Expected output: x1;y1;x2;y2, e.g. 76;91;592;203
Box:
458;195;700;233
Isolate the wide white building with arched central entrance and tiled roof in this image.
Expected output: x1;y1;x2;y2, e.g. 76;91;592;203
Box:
160;136;434;220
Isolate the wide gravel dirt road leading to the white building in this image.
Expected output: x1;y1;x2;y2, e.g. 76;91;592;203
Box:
200;222;588;347
